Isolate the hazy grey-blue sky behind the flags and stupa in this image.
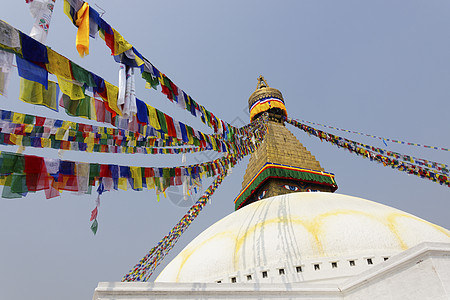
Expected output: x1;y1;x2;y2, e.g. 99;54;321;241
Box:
0;0;450;300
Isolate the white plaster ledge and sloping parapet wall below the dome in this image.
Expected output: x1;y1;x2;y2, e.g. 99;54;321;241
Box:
93;243;450;300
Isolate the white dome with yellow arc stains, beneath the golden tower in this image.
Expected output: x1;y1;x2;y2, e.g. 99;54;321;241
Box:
156;193;450;283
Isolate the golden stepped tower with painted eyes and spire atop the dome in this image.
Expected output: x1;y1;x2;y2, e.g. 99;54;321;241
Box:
235;76;337;209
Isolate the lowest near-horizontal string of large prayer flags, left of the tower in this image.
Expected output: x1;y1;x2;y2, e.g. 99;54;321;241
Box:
0;151;244;198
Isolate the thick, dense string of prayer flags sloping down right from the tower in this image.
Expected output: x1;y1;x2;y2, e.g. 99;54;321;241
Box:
285;118;450;187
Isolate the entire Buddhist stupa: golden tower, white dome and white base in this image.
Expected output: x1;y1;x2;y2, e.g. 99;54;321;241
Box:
94;76;450;299
